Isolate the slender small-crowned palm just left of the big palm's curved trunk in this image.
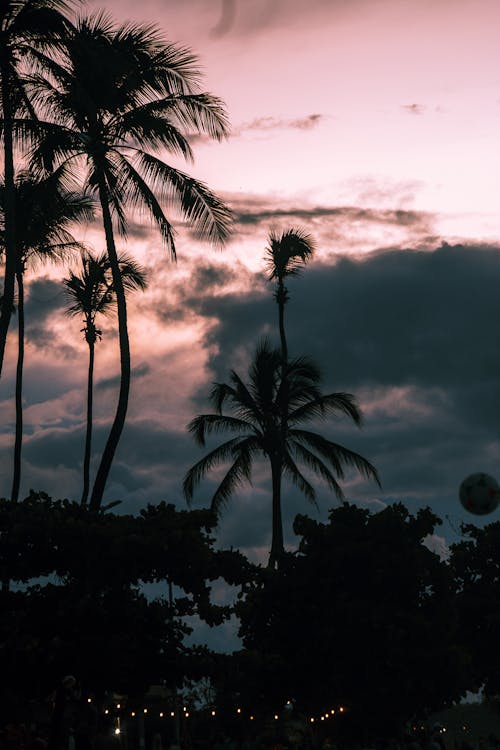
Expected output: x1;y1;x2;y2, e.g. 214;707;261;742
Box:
64;253;146;507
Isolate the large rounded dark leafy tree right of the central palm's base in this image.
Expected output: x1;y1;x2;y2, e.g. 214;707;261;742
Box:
236;503;469;742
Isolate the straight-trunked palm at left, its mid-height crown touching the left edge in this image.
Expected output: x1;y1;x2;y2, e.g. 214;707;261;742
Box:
0;169;93;502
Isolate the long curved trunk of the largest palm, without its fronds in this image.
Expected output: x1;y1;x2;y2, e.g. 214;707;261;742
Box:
89;175;130;510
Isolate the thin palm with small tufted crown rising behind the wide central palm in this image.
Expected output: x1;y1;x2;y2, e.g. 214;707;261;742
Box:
264;229;316;366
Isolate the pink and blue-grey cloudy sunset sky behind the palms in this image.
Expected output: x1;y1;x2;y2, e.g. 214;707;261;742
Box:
0;0;500;648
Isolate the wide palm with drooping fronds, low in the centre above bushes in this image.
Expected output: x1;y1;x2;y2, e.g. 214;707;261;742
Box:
183;341;380;567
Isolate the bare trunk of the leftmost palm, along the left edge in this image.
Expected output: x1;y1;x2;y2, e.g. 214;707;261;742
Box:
0;75;17;376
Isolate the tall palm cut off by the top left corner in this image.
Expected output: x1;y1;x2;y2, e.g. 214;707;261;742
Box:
0;0;73;382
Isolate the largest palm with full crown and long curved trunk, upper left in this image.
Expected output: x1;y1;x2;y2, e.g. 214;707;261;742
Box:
33;14;230;510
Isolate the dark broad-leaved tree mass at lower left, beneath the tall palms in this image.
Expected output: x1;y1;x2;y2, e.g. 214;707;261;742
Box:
0;493;252;725
